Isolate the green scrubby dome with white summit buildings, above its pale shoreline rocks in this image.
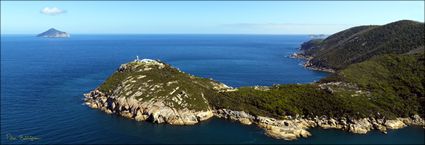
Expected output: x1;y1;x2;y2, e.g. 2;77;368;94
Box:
98;62;224;110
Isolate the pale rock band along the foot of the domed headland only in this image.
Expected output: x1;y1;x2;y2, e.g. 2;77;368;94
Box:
84;89;213;125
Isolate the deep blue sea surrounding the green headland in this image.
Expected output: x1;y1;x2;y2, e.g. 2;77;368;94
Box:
1;35;424;144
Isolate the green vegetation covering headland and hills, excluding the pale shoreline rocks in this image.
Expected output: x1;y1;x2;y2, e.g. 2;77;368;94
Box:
94;21;425;118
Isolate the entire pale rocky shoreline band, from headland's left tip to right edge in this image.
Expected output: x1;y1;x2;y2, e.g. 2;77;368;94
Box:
84;90;425;140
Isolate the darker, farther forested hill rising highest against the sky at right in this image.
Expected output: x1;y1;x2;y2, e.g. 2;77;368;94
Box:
301;20;425;70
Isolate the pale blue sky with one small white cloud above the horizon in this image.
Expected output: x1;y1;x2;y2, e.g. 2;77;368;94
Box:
1;1;424;34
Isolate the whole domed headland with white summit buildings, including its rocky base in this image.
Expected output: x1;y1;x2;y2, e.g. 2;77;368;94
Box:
85;59;228;125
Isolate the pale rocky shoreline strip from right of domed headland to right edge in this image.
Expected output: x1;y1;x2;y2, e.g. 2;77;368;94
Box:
214;109;425;140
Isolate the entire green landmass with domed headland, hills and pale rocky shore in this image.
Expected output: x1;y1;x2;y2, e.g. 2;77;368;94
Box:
84;20;425;140
